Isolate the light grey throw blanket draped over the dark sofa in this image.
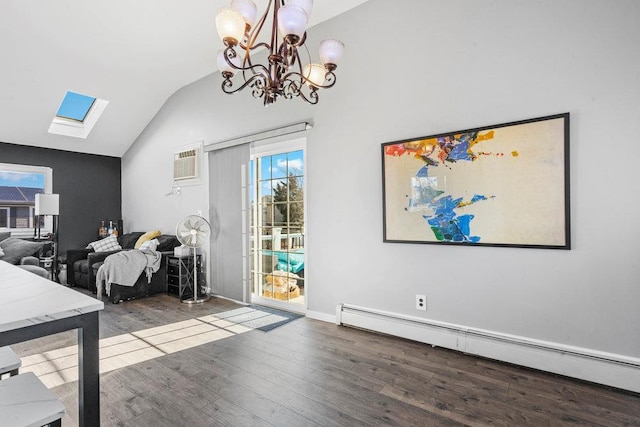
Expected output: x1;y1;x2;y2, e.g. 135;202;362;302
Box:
96;249;162;299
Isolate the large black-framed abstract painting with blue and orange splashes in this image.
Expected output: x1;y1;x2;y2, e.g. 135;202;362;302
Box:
382;113;570;249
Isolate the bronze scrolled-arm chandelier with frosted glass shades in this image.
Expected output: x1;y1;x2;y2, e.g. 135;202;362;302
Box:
216;0;344;106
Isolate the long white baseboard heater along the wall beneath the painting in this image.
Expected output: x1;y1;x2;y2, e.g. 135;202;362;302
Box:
336;304;640;393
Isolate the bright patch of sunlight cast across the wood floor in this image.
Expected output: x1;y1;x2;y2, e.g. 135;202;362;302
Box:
20;307;283;388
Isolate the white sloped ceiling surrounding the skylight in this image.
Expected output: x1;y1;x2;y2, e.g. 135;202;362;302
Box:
0;0;366;157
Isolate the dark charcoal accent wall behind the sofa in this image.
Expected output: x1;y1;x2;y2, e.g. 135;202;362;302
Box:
0;141;122;254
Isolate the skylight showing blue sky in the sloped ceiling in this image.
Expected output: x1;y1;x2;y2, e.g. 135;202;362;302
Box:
49;92;109;139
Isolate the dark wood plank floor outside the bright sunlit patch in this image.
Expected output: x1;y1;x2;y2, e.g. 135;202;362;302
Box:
12;295;640;427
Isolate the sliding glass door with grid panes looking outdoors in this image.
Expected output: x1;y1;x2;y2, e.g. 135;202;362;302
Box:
250;140;306;312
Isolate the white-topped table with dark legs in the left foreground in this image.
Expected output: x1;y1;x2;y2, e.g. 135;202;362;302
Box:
0;261;104;427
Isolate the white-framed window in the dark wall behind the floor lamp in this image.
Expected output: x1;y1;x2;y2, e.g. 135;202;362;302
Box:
0;163;53;236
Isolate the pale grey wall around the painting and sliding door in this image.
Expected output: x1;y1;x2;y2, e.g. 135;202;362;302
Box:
122;0;640;357
